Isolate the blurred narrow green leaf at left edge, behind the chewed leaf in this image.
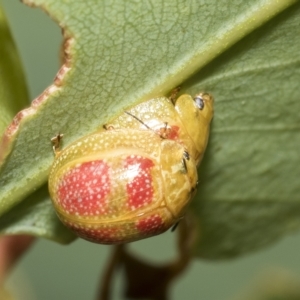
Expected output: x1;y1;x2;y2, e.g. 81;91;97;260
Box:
0;7;29;134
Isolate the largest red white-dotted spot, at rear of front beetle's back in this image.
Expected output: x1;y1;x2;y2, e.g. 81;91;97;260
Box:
58;160;110;216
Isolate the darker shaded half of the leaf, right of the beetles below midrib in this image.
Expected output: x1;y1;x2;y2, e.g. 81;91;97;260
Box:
192;3;300;259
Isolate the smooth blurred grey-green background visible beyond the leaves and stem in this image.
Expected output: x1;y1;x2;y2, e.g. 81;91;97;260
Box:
0;0;300;300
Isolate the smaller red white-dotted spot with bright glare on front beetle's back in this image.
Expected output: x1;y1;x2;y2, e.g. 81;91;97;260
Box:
125;155;154;209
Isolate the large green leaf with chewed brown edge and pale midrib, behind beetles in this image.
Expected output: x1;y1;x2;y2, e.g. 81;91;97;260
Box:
0;0;300;258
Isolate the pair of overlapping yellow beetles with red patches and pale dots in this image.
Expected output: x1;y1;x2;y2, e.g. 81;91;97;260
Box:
49;94;213;244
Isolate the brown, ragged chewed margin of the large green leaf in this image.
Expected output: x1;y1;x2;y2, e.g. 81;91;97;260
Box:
0;0;74;167
